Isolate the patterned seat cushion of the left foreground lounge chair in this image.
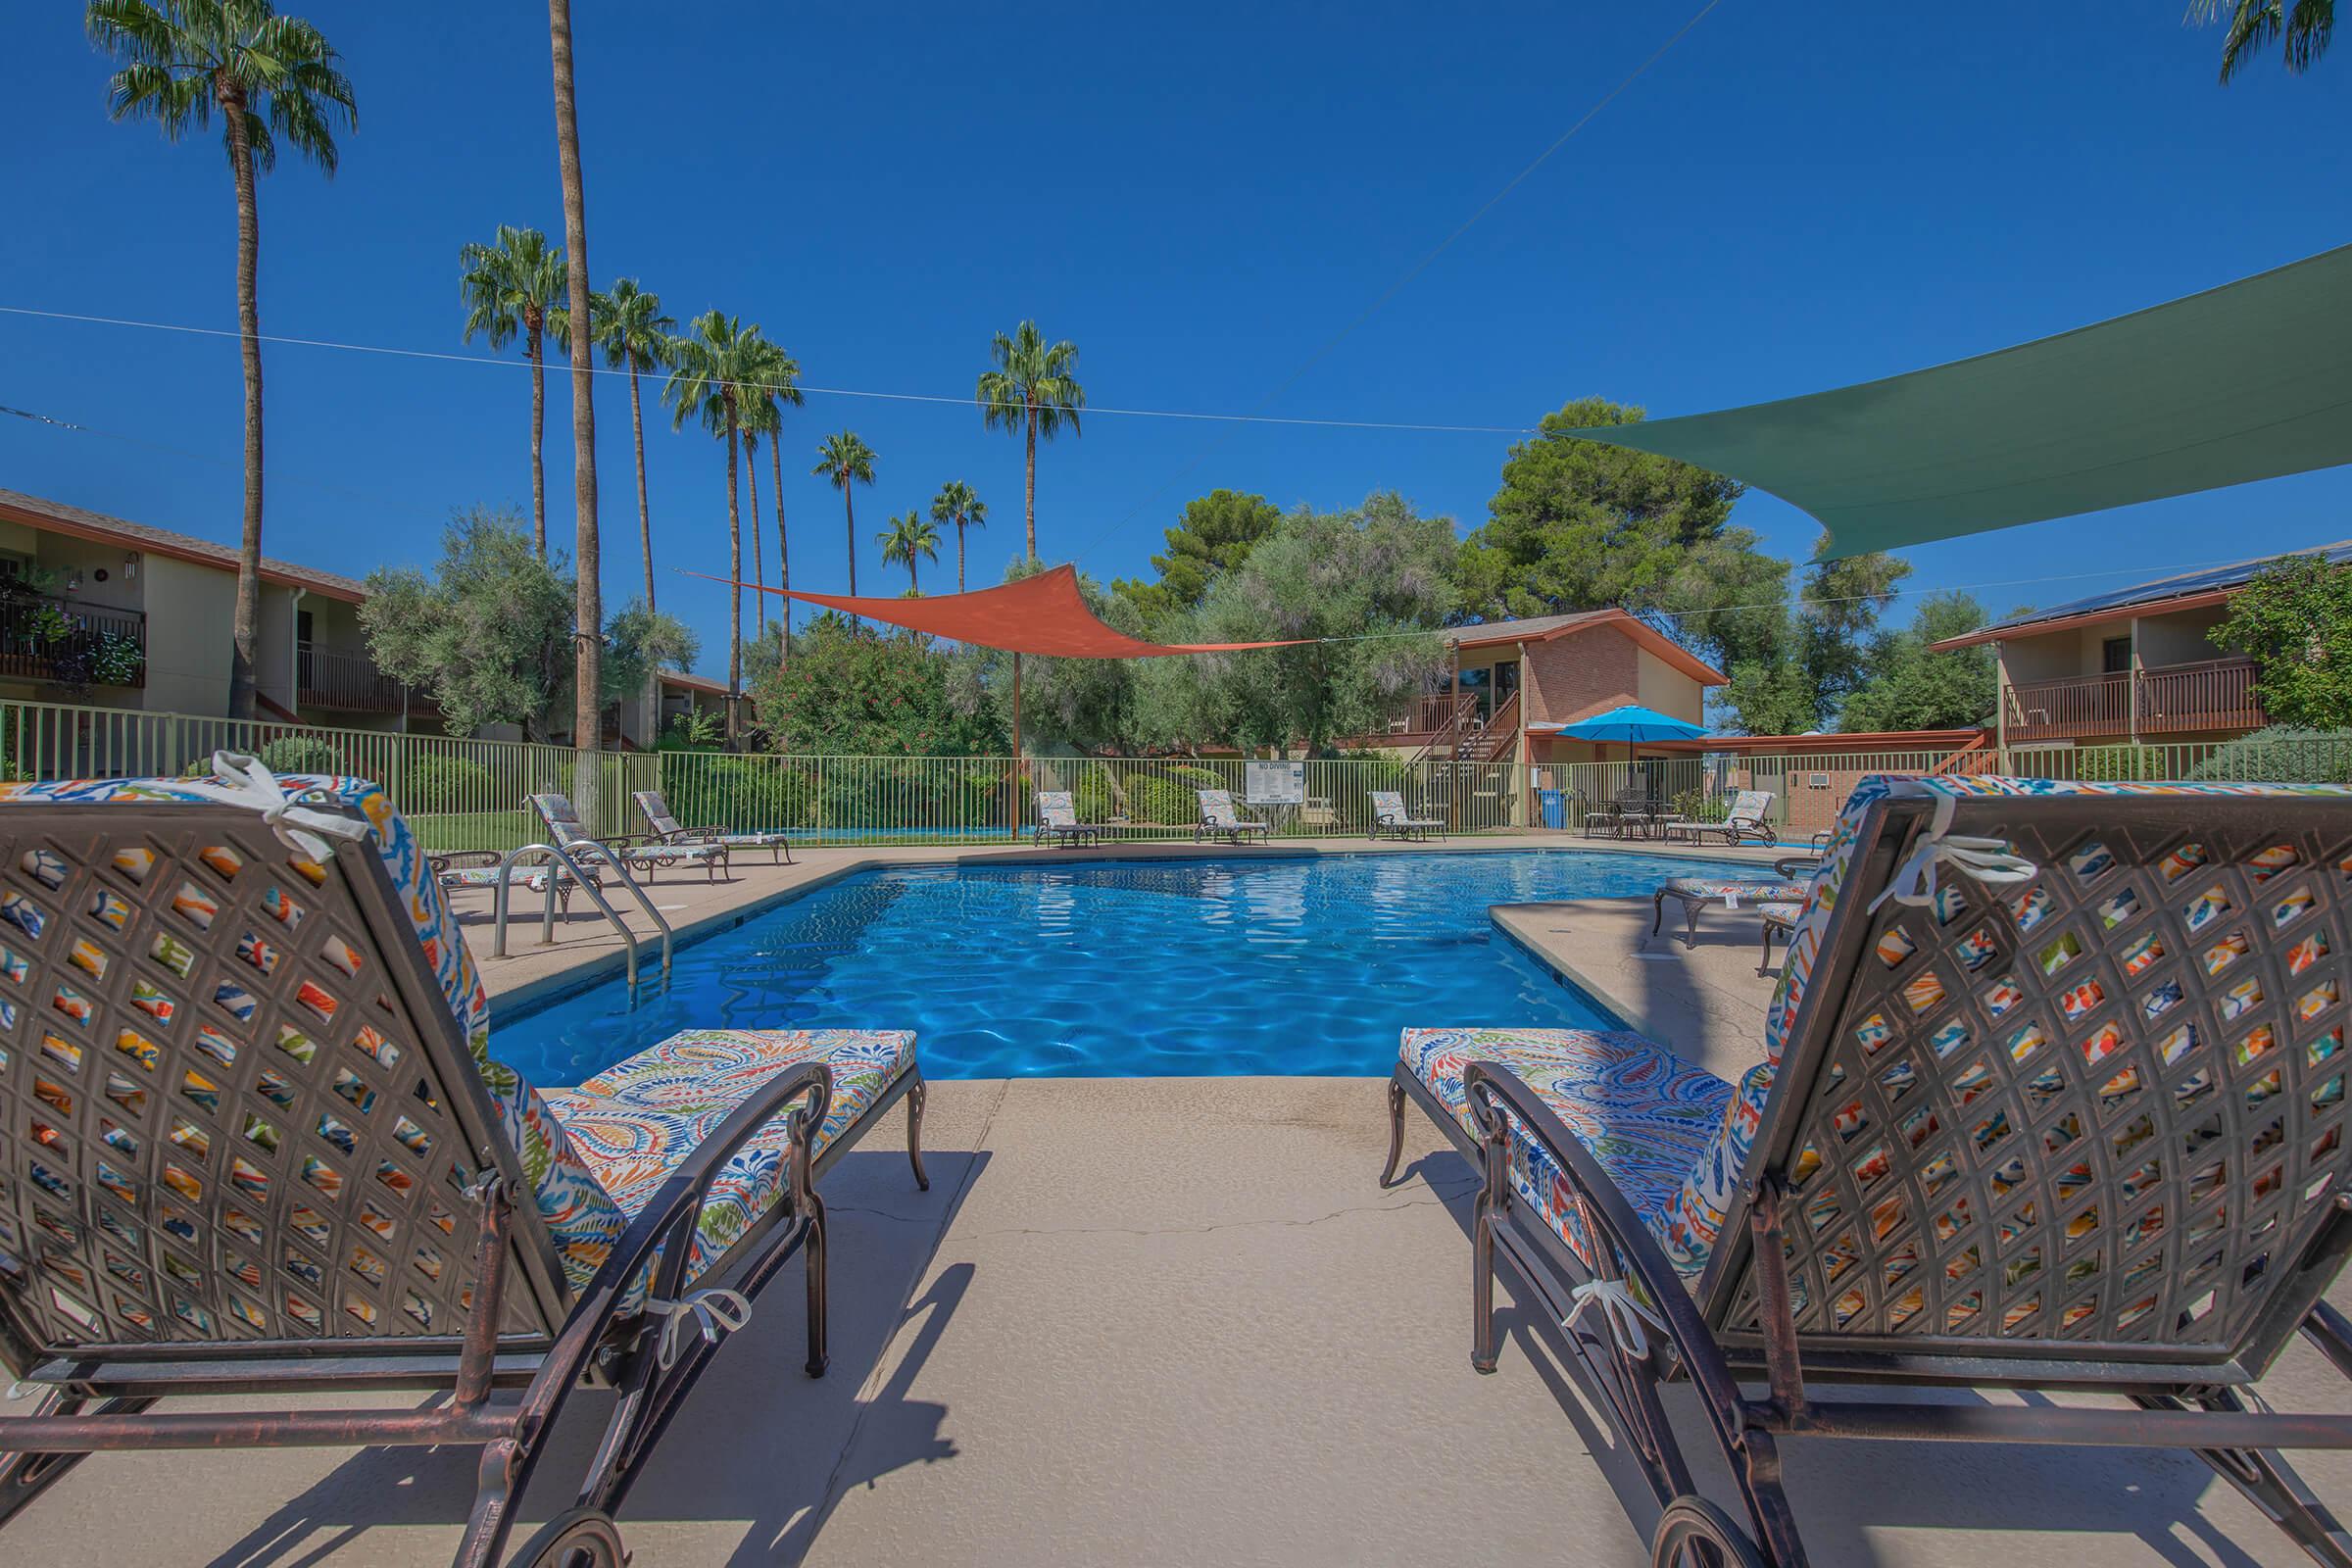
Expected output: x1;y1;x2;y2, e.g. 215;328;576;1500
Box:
546;1030;915;1277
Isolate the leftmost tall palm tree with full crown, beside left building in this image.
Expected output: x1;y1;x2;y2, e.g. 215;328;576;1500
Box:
82;0;360;719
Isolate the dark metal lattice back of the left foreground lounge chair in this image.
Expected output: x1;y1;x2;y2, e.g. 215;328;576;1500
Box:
0;802;563;1371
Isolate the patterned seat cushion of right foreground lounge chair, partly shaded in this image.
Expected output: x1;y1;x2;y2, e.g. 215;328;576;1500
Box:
1397;1030;1731;1260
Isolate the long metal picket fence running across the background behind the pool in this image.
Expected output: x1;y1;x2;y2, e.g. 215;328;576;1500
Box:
0;701;2352;849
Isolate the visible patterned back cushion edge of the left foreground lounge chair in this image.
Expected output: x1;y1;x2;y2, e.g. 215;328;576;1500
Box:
0;773;628;1291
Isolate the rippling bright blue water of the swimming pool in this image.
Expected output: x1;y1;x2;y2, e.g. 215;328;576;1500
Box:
492;851;1757;1084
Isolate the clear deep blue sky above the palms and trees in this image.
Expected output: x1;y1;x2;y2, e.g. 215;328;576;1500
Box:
0;0;2352;672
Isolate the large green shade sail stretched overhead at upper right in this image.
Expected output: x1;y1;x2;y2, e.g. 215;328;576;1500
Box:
1566;244;2352;560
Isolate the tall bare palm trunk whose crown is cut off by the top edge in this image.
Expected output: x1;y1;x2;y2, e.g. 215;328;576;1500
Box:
550;0;605;775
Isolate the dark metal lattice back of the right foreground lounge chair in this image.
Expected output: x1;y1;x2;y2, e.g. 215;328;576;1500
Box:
1698;783;2352;1380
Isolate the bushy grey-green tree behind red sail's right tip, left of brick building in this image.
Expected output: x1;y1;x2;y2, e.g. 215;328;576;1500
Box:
1136;494;1458;755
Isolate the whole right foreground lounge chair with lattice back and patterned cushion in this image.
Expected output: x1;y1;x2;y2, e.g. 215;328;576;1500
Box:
1383;778;2352;1568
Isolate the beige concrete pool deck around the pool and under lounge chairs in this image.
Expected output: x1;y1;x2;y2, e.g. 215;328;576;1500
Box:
0;837;2352;1568
